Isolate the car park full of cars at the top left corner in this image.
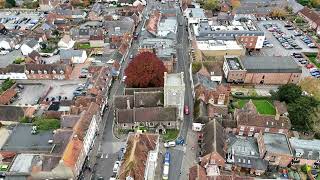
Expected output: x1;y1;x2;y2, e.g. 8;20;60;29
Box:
0;11;43;30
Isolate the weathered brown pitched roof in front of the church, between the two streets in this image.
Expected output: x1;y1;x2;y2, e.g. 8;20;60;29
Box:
118;133;159;180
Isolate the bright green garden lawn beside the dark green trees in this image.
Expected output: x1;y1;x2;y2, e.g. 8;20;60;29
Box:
237;100;276;115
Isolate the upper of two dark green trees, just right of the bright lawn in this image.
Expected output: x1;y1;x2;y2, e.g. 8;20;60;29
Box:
274;84;302;103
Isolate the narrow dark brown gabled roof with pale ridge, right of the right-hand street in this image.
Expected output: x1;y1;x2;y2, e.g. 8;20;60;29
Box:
202;119;225;158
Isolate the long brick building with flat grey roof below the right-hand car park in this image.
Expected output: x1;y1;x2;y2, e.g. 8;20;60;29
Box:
223;56;302;84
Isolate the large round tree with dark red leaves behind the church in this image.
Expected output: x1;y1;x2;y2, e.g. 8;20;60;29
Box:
124;52;167;88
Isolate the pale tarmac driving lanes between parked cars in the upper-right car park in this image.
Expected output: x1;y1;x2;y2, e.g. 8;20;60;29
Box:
257;20;318;56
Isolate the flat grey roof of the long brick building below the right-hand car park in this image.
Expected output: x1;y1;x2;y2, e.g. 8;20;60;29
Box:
241;56;302;73
